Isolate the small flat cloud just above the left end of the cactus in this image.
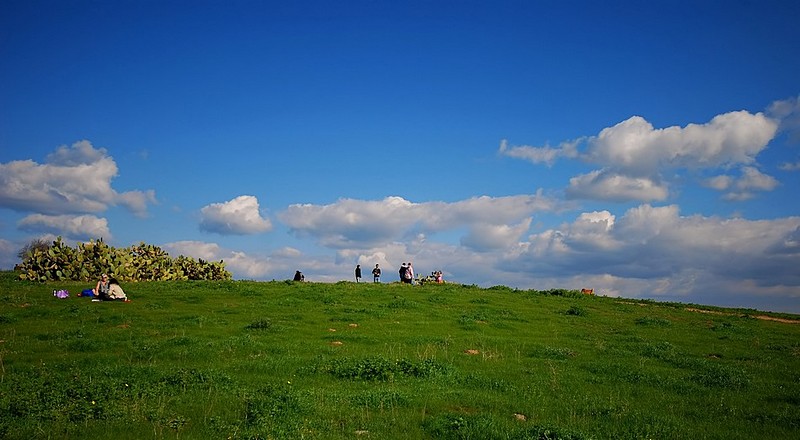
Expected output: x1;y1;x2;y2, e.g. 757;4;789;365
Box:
17;214;112;241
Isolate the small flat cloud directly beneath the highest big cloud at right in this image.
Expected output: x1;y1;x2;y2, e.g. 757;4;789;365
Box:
566;170;669;202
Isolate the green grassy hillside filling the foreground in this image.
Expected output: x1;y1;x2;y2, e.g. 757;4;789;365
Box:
0;272;800;439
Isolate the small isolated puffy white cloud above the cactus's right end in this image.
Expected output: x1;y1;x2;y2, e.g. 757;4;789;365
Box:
200;196;272;235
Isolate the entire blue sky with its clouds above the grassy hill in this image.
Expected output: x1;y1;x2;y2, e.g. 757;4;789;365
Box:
0;0;800;313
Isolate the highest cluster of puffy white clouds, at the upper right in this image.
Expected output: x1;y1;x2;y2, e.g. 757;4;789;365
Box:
499;103;780;202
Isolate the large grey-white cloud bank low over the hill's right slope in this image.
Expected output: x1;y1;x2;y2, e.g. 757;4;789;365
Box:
502;205;800;296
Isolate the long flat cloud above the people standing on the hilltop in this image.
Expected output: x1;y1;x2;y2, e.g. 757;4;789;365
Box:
279;192;559;249
